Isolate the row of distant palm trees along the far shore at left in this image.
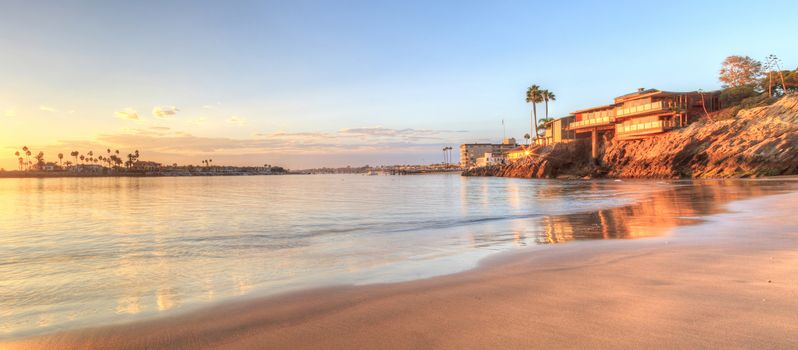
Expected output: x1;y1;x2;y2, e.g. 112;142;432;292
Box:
14;146;139;171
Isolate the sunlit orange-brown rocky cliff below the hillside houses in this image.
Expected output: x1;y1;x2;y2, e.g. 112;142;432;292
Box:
464;94;798;178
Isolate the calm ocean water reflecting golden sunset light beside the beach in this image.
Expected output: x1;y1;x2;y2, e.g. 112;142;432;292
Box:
0;175;792;338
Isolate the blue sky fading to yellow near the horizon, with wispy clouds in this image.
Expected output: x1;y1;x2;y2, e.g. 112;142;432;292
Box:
0;0;798;170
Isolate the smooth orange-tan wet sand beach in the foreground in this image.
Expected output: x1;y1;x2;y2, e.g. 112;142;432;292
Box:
6;193;798;349
